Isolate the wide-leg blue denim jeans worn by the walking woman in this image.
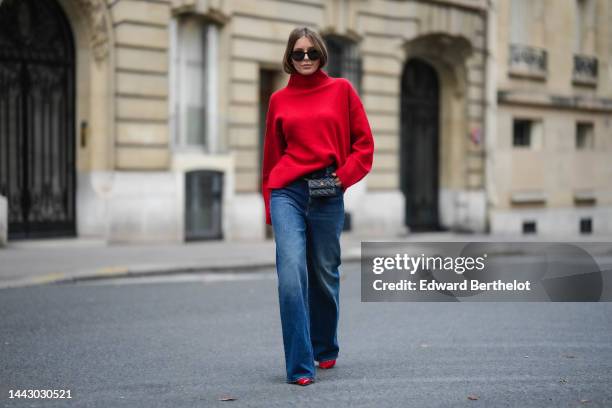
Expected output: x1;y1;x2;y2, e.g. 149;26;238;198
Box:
270;171;344;382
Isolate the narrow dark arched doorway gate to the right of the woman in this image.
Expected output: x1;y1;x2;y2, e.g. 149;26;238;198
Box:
400;59;439;231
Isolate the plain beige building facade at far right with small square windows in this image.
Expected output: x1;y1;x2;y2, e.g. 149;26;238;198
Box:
487;0;612;237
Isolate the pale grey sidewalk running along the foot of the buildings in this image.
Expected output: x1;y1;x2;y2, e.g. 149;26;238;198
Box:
0;232;612;289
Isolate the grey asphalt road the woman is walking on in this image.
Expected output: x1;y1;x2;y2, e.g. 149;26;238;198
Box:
0;265;612;408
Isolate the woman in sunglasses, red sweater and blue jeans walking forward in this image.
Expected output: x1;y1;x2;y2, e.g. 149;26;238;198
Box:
262;27;374;385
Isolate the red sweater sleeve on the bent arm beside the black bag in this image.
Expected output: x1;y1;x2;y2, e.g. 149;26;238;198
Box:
336;81;374;190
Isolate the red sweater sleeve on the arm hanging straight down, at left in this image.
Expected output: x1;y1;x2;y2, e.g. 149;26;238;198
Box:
261;95;287;225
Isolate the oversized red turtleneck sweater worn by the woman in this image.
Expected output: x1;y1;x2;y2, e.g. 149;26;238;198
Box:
262;69;374;224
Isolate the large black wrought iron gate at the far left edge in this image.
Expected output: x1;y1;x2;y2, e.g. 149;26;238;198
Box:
0;0;76;239
